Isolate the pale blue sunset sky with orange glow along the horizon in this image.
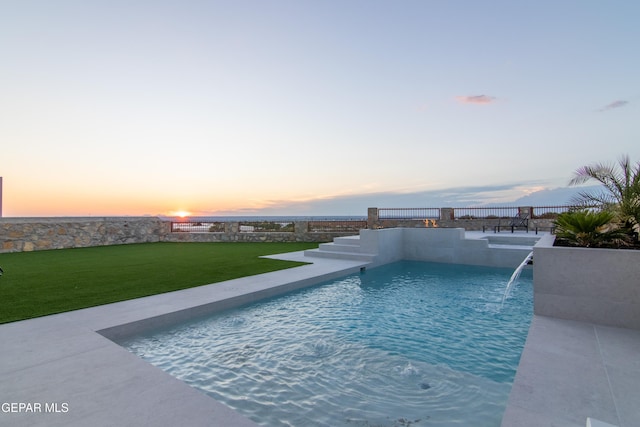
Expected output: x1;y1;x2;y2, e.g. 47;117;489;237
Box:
0;0;640;217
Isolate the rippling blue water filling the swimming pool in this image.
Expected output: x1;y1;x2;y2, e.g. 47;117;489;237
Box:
121;261;533;427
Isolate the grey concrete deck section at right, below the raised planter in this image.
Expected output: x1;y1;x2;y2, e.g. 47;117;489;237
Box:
502;315;640;427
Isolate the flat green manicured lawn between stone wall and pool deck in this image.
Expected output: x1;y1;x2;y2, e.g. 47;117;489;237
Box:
0;243;317;323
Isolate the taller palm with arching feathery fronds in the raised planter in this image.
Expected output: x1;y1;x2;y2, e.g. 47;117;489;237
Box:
569;155;640;232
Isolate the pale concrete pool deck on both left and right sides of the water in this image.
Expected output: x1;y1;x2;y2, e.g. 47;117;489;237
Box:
0;236;640;427
